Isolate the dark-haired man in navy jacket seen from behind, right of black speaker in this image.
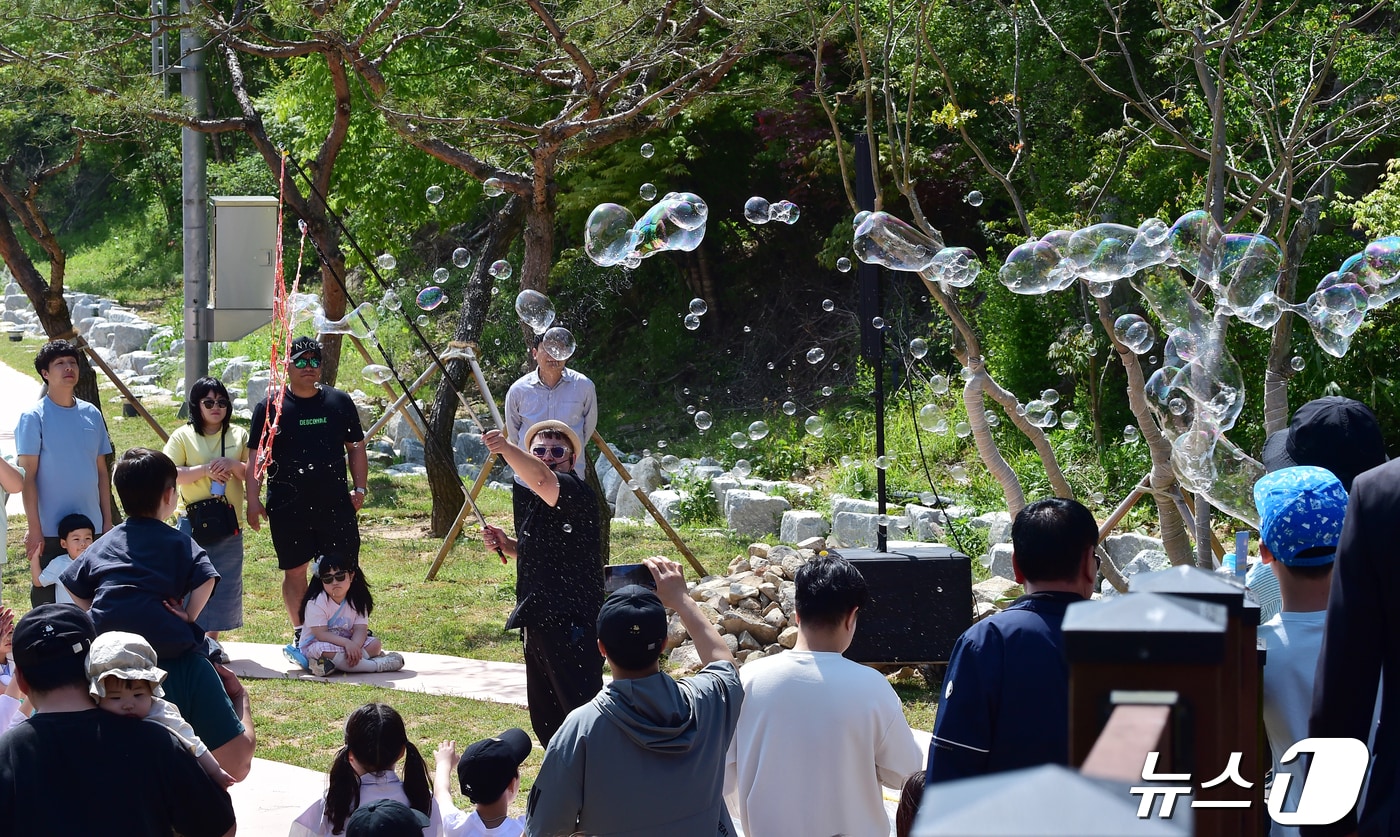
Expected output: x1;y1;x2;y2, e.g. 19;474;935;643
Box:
925;498;1099;785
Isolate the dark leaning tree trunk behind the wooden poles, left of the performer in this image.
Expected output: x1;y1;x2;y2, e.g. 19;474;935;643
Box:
424;196;525;537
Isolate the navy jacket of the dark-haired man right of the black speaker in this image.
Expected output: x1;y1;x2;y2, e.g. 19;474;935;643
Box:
925;592;1084;785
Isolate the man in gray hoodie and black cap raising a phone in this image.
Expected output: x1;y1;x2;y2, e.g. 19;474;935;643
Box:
525;558;743;837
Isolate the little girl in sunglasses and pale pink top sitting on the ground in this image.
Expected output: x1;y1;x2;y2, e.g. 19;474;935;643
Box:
301;553;403;677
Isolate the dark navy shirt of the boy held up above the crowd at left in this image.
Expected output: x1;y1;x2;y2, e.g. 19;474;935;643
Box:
60;518;218;659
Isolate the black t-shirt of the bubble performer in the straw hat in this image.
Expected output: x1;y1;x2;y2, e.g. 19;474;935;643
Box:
505;472;603;628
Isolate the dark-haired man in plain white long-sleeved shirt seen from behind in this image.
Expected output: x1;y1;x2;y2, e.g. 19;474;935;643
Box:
725;556;924;837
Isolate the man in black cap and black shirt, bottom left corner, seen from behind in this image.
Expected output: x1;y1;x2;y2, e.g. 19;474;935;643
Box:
0;605;235;837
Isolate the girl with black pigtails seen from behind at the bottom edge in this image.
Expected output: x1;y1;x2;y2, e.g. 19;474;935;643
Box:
290;703;442;837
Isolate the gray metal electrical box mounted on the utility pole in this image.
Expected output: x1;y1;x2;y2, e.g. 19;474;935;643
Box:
200;196;277;342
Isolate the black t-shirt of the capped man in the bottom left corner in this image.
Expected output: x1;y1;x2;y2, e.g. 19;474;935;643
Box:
0;708;234;837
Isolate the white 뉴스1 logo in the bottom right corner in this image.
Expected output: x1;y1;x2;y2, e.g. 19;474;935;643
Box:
1131;738;1371;826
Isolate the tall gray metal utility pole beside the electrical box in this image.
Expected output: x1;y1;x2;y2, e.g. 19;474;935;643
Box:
179;0;209;389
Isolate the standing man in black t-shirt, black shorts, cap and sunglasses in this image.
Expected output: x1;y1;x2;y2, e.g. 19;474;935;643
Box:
246;337;370;668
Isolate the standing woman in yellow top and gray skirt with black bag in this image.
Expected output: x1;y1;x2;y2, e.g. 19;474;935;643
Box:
165;378;248;662
